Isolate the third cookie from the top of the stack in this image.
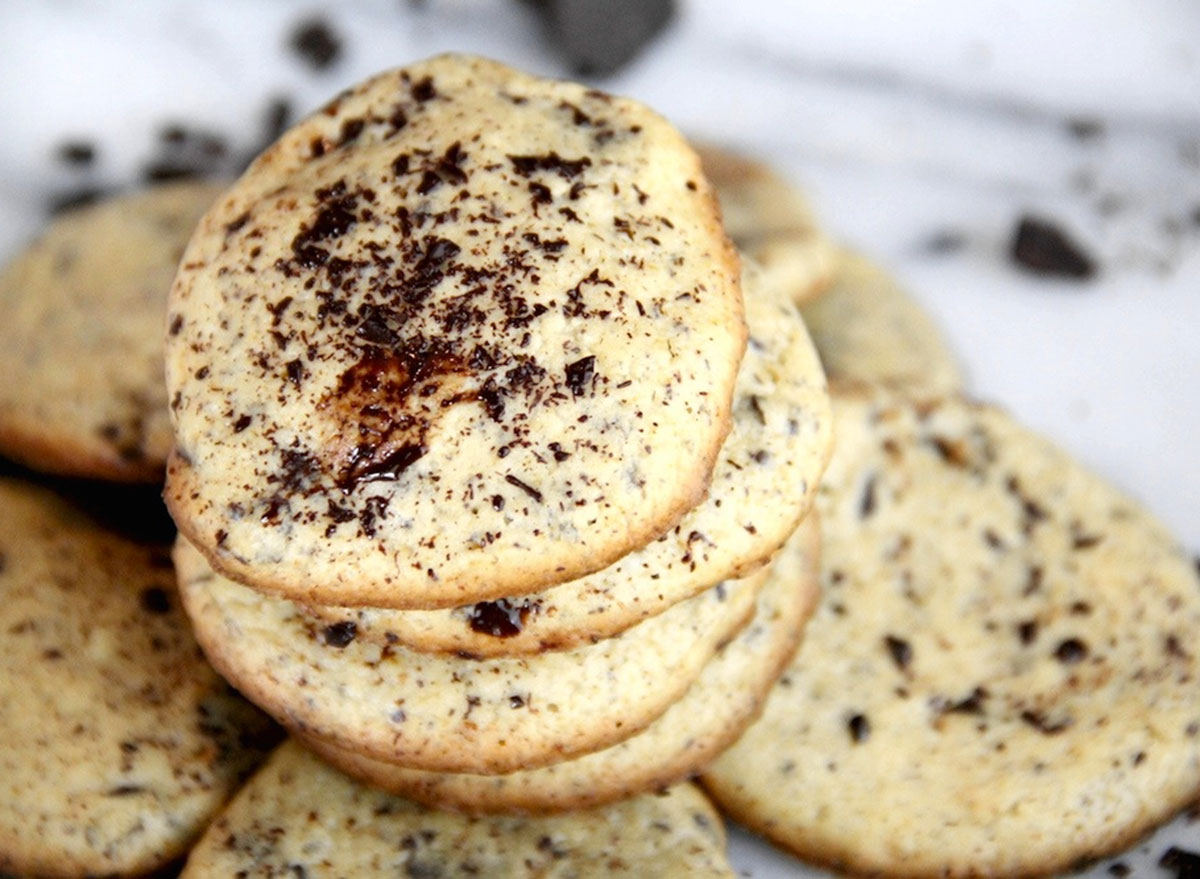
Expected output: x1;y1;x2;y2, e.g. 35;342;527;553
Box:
175;540;766;773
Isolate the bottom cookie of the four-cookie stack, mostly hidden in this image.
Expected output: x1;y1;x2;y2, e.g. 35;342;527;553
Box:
304;520;818;814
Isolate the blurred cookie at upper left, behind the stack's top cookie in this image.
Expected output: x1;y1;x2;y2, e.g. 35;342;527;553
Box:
0;183;222;482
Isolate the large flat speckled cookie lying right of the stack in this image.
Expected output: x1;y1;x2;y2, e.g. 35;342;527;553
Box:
704;395;1200;877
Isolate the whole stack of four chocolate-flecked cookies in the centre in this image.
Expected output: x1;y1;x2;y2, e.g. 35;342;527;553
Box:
167;56;830;812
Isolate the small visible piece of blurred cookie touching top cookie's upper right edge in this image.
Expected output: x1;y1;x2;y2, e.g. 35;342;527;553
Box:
697;145;835;303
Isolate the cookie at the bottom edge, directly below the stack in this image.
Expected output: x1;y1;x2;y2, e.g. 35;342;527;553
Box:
181;742;734;879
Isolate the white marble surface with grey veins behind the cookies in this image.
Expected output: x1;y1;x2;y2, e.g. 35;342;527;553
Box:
0;0;1200;879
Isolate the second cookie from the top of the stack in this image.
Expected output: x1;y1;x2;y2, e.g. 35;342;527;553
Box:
297;268;832;657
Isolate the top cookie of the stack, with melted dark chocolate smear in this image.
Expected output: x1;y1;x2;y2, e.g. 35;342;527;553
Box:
167;55;745;609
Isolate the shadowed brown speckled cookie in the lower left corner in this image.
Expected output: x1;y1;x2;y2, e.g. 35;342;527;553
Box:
0;479;276;877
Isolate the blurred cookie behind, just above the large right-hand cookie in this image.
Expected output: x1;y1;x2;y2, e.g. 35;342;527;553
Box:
803;250;962;396
